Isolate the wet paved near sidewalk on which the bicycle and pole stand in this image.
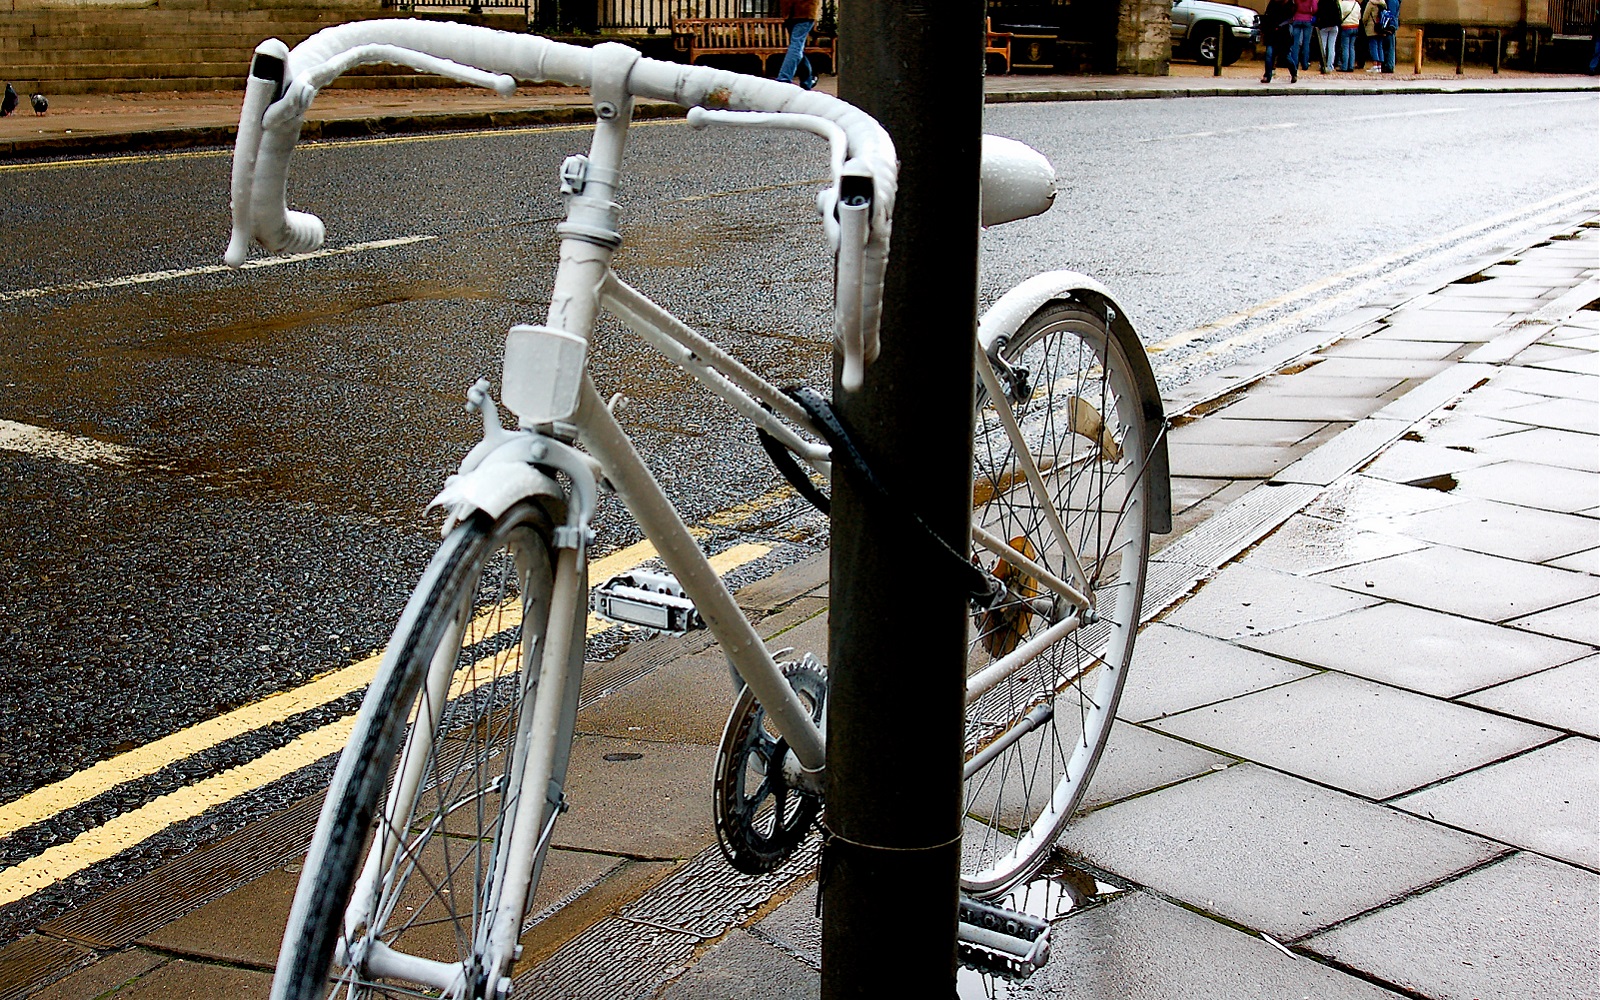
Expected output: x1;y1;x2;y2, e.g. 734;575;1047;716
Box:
0;204;1600;1000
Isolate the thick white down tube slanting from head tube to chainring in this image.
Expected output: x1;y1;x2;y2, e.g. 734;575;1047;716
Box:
578;374;822;771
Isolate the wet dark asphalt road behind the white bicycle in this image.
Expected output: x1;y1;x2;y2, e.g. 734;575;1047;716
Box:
0;94;1600;921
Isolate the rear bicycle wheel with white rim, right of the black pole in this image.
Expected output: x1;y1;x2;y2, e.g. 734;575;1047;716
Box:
962;299;1154;898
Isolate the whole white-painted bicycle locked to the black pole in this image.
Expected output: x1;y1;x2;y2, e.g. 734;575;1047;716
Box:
227;21;1170;1000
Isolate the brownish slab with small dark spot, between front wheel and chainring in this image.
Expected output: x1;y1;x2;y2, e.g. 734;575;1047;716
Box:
554;734;717;859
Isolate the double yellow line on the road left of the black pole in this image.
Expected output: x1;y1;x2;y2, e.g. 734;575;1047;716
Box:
0;541;771;906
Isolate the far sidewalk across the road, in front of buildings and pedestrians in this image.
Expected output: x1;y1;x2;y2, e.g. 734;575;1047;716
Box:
0;62;1600;160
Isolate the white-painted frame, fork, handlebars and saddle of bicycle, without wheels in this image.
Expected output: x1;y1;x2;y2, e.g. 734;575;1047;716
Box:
227;21;1158;995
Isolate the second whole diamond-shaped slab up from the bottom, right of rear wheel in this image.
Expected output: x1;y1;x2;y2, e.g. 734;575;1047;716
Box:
1150;674;1557;798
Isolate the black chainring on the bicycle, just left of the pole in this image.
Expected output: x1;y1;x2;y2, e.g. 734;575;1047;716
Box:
712;653;827;875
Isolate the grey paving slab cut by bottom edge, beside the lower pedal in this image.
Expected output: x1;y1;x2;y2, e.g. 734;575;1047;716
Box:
992;893;1395;1000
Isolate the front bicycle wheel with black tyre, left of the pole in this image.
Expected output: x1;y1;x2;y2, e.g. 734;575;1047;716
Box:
272;502;582;1000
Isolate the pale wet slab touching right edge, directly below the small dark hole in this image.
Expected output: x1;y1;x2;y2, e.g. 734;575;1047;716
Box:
1400;499;1600;563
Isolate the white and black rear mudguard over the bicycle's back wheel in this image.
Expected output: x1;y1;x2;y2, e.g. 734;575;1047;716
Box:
978;270;1173;534
